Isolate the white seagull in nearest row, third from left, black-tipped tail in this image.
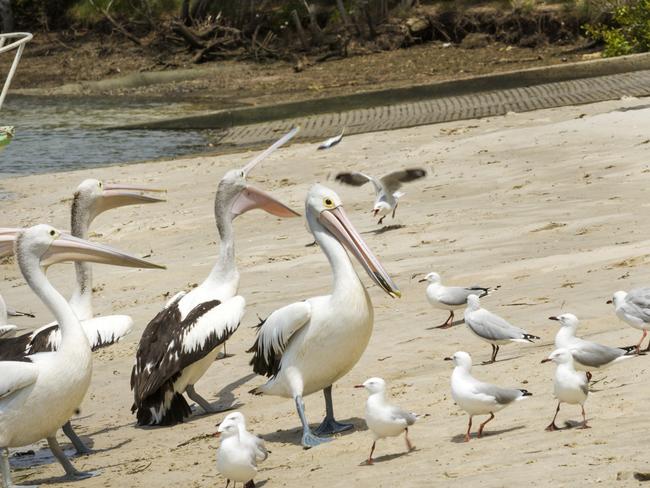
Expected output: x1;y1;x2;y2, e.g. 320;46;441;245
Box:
445;351;532;442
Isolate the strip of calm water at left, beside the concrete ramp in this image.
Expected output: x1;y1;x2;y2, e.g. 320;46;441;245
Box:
0;92;228;178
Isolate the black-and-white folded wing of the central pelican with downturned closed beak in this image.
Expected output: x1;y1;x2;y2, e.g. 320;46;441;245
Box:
248;302;311;377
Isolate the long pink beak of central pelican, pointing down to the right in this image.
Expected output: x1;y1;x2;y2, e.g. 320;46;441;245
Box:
318;206;402;298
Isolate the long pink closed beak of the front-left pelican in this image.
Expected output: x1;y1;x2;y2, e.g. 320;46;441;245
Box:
41;234;166;269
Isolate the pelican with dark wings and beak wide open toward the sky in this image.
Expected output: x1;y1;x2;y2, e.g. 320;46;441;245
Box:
131;129;298;425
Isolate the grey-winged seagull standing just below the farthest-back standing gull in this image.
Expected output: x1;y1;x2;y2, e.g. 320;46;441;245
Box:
464;295;539;364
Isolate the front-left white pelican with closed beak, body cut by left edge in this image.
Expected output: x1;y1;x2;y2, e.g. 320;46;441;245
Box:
0;224;162;488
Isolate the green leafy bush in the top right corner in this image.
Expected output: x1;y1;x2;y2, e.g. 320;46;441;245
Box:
585;0;650;57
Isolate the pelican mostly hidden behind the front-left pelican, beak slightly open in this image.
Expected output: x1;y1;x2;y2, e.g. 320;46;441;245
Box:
0;179;164;454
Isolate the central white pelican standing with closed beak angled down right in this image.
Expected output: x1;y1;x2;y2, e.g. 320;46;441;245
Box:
249;184;401;448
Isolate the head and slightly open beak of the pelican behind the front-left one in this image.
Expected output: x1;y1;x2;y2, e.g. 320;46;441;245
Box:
72;178;166;228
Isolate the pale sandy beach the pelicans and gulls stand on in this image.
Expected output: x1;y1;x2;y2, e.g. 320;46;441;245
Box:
0;99;650;487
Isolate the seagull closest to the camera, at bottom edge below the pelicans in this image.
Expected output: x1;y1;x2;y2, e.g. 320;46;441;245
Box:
217;418;258;488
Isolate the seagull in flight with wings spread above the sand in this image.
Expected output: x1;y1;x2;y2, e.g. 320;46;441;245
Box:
334;168;427;225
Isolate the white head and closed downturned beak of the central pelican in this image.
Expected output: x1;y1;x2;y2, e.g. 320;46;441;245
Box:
305;183;402;297
